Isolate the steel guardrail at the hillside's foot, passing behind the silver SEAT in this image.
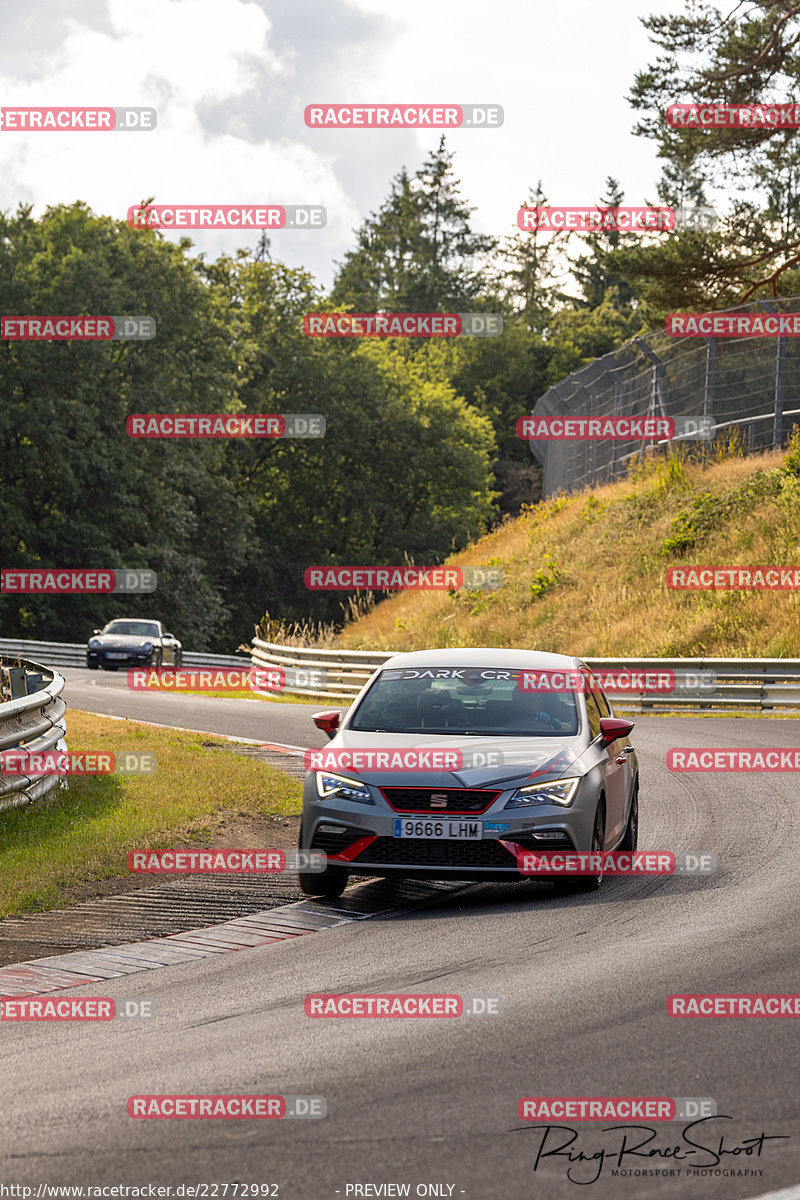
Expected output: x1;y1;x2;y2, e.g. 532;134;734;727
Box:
251;637;800;713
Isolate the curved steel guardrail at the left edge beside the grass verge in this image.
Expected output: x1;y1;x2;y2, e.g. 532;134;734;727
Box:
0;654;67;814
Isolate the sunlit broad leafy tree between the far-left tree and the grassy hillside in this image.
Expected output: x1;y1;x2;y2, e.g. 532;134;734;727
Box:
209;257;495;620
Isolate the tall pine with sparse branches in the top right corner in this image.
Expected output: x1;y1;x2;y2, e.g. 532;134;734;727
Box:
616;0;800;304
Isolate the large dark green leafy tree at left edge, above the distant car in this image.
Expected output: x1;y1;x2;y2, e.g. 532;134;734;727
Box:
0;204;248;649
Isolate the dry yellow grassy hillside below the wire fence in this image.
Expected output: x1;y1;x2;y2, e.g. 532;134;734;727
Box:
337;434;800;658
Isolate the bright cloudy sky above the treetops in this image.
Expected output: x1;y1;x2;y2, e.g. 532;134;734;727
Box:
0;0;684;286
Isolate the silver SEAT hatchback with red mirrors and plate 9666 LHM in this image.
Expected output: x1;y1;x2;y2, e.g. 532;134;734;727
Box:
300;649;639;898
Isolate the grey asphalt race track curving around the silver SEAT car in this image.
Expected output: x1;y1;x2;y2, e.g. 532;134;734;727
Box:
0;671;800;1200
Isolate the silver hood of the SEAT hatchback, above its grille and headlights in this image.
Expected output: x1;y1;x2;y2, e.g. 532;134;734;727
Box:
318;730;585;787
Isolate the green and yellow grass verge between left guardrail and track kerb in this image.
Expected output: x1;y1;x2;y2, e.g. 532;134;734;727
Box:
0;709;302;917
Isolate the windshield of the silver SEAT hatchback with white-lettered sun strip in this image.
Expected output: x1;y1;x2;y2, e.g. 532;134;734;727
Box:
348;667;578;738
